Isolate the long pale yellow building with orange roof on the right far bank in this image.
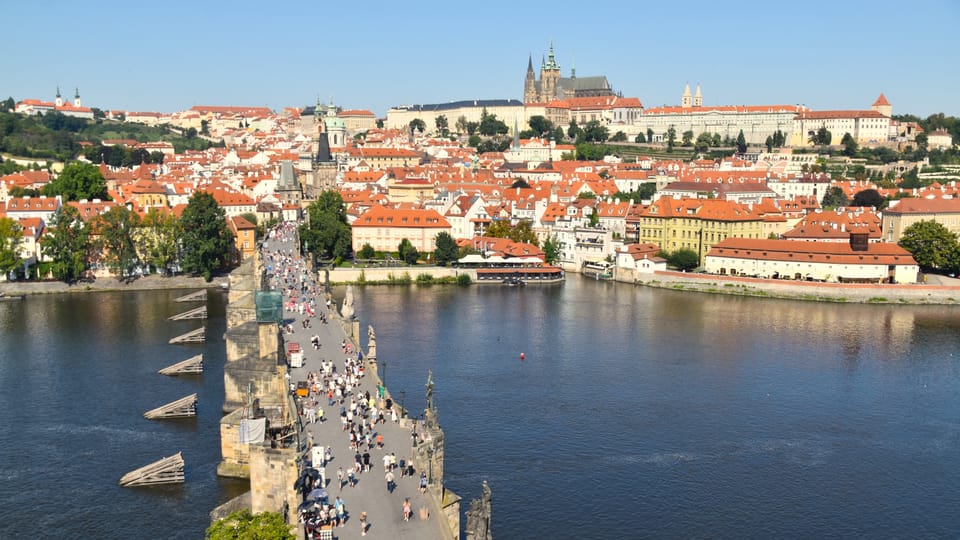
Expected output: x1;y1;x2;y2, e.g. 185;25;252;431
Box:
639;197;763;264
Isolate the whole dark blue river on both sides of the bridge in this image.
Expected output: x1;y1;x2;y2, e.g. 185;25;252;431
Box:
0;275;960;539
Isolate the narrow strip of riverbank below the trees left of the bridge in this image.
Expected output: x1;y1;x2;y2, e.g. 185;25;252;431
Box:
0;275;229;296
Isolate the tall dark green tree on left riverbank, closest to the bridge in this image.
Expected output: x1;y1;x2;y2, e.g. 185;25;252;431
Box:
180;191;233;281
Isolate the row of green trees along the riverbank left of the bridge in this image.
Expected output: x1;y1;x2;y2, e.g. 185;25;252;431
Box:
0;192;233;283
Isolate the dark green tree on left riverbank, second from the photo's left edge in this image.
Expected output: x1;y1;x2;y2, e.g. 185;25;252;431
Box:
41;204;91;283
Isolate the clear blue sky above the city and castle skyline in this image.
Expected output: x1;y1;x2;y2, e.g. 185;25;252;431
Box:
0;0;960;116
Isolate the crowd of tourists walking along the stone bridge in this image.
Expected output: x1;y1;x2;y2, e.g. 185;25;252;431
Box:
264;223;427;539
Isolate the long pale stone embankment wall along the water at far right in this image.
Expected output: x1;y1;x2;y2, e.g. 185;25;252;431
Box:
615;271;960;305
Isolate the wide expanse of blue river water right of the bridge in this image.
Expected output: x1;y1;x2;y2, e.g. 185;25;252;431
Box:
356;276;960;538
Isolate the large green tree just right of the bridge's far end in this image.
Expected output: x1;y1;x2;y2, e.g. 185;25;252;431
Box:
300;190;353;259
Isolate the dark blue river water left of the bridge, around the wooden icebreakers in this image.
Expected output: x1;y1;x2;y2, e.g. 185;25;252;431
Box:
0;291;251;539
